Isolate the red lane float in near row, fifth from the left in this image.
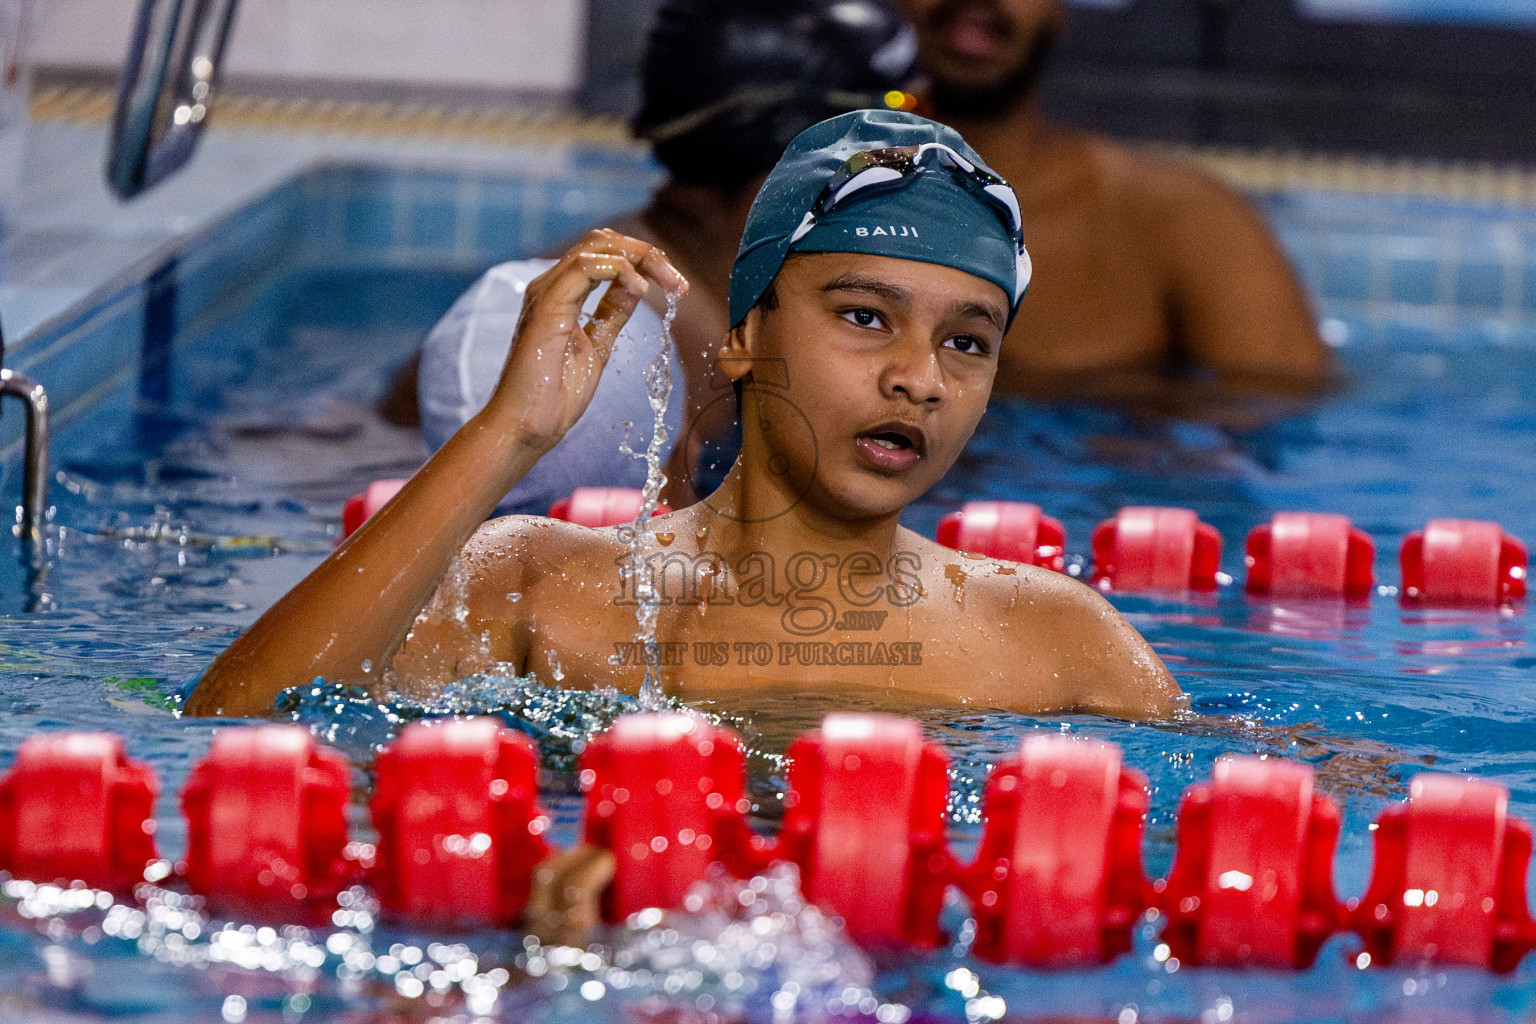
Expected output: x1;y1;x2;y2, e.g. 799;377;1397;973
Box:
777;714;952;947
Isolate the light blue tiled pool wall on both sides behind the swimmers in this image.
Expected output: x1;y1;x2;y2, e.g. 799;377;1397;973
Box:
9;166;1536;478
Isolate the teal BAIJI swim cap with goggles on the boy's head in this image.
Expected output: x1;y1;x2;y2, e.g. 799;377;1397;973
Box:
731;111;1031;327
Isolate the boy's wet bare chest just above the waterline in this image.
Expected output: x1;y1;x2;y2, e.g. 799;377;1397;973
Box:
519;559;1052;709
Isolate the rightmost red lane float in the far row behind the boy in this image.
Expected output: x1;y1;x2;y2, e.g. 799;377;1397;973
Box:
1398;519;1528;606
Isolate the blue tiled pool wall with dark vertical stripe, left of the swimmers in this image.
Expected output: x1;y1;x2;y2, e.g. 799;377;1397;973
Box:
0;152;654;482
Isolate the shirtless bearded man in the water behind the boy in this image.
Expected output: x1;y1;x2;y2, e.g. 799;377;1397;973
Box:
899;0;1330;398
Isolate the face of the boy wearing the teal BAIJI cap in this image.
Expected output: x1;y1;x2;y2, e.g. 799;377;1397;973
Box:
722;253;1008;519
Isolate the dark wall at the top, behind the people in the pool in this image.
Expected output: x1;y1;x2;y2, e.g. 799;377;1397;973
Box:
582;0;1536;163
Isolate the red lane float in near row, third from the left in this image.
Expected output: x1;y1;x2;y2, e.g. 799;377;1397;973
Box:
369;718;550;926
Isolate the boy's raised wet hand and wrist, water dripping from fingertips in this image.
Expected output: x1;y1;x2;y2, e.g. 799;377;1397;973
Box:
485;229;688;450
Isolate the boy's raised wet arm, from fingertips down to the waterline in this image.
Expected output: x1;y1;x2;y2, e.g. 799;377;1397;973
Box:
186;230;688;715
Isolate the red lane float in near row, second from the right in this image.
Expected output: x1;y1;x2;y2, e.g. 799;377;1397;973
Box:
1161;757;1342;967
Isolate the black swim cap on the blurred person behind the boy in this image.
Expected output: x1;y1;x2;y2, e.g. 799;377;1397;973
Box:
634;0;917;190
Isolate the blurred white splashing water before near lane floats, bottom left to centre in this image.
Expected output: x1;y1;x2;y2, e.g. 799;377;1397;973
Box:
0;851;911;1024
